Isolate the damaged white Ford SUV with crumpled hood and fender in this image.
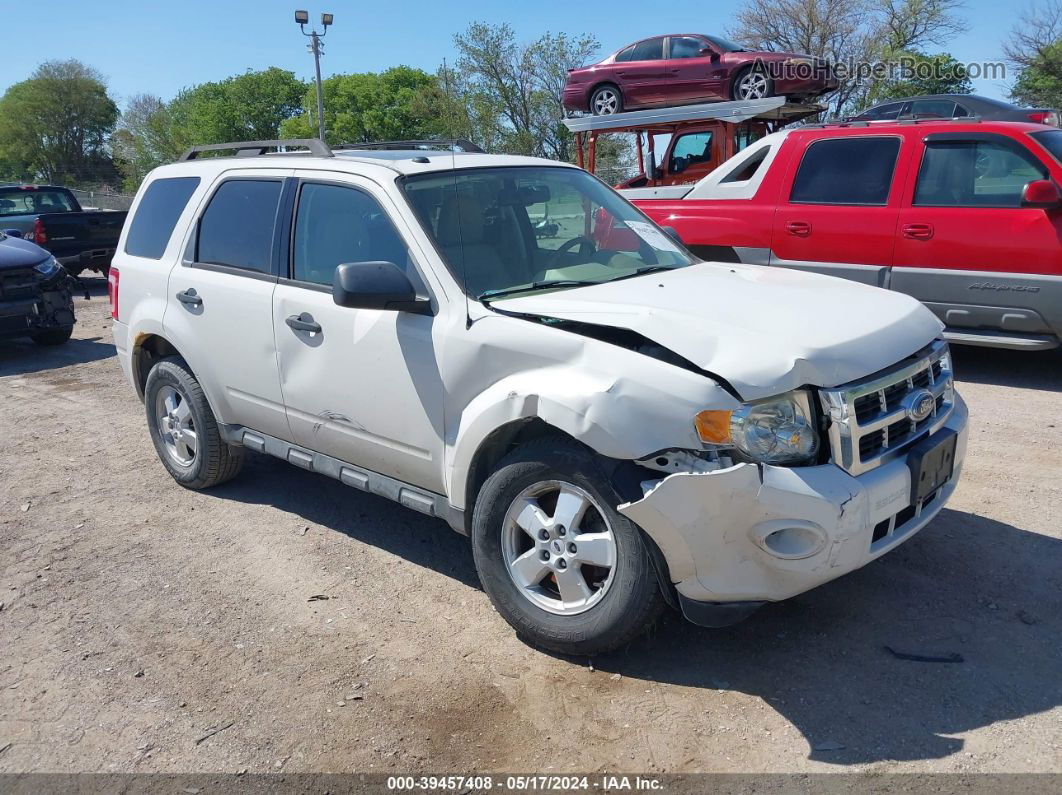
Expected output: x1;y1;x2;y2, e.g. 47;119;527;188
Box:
110;140;966;654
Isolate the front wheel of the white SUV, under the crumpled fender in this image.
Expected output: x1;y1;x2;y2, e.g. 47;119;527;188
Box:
472;437;664;655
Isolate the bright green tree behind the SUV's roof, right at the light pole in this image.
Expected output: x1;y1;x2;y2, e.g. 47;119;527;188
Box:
280;66;445;143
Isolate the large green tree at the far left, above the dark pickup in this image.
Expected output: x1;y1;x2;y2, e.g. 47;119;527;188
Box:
0;61;118;183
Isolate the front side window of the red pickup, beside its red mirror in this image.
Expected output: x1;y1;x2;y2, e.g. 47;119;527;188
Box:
914;140;1047;207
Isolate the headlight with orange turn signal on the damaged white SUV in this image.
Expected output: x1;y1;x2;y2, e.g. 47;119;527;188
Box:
693;390;819;464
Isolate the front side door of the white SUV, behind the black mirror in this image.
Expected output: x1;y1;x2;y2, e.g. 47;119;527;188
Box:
273;173;444;491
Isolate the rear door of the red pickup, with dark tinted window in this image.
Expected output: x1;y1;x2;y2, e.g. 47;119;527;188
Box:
770;133;907;287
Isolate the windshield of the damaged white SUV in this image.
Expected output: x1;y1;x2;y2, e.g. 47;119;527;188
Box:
401;166;695;298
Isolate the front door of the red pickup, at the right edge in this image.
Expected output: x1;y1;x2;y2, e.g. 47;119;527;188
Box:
892;132;1062;336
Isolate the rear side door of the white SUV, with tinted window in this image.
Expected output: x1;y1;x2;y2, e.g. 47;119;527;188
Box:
163;169;291;438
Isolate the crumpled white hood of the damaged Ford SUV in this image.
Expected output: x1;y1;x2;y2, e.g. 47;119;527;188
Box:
494;262;943;400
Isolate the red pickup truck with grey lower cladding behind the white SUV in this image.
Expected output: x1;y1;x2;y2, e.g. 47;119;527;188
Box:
622;120;1062;350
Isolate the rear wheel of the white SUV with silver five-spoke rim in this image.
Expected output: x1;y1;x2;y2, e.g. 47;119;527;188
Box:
143;357;243;489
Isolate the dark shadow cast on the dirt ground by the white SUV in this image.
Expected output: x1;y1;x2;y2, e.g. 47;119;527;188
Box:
212;456;1062;765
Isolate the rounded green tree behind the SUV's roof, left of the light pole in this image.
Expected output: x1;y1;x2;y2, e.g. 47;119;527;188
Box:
168;67;306;150
